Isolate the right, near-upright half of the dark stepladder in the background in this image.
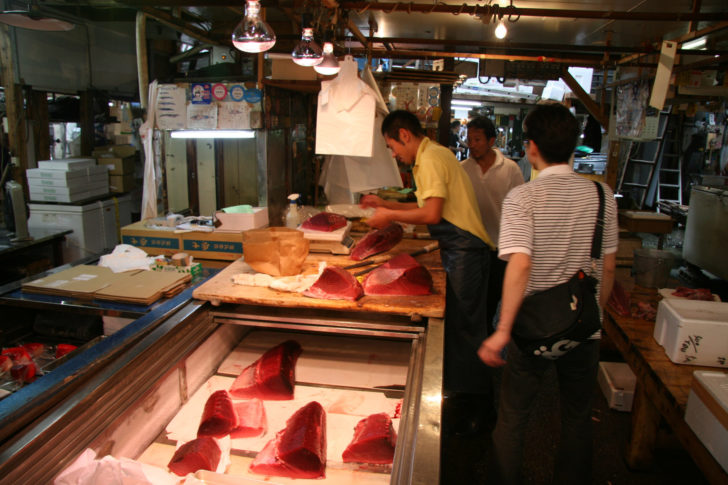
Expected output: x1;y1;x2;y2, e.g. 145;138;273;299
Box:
657;115;682;205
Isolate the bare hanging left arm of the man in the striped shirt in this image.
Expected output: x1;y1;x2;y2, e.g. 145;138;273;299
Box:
478;253;531;367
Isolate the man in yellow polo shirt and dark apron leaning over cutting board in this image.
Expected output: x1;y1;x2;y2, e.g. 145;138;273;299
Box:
360;110;495;434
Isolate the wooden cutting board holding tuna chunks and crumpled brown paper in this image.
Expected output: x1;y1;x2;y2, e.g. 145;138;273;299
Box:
193;239;445;318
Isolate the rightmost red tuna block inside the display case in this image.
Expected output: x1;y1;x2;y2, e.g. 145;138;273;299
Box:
341;413;397;464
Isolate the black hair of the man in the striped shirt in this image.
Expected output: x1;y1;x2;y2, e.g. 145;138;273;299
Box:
523;103;579;163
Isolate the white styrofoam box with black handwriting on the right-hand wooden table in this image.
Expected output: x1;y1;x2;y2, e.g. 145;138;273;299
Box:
653;298;728;368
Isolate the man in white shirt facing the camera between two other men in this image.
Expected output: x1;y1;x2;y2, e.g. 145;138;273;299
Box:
460;116;523;325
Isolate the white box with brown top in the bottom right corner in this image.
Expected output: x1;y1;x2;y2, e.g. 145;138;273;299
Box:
685;371;728;472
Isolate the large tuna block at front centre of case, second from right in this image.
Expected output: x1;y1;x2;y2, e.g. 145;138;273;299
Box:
250;401;326;478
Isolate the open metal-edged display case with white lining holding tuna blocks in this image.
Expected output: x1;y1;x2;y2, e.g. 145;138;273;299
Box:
0;299;443;484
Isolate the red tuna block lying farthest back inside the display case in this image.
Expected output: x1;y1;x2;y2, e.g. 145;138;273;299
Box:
230;340;301;401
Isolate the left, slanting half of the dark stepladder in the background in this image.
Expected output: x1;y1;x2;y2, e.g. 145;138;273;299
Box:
617;111;670;209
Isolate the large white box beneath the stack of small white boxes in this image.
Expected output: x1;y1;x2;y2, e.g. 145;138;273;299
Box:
28;194;131;263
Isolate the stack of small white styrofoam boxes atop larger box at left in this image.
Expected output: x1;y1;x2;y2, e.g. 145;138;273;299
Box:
25;158;109;202
